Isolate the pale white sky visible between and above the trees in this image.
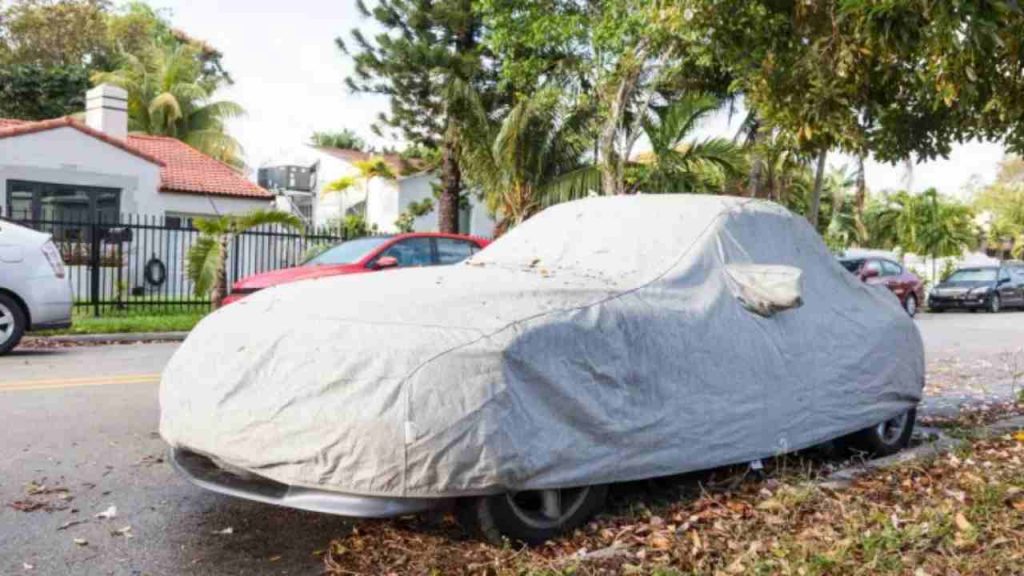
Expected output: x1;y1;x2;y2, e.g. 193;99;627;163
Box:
138;0;1004;195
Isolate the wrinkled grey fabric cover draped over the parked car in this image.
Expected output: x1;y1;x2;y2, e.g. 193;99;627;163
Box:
160;195;924;497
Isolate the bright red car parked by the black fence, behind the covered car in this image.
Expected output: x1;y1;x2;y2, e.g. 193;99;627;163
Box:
223;233;490;304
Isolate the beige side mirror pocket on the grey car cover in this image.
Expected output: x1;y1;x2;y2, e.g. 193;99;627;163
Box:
725;264;804;318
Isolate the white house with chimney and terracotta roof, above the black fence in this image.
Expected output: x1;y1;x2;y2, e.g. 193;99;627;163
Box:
0;85;273;225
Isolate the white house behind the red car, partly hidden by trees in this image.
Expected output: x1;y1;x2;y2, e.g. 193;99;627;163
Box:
260;146;495;237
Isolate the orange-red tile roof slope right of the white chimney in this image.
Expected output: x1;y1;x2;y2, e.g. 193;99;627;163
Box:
128;134;273;200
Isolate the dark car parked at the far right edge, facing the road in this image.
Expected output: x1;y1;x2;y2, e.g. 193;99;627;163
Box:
928;264;1024;313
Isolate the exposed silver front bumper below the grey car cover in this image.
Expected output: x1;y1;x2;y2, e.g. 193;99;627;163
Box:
171;448;447;518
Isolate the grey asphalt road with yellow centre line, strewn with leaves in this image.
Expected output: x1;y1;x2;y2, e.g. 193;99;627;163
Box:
0;313;1024;575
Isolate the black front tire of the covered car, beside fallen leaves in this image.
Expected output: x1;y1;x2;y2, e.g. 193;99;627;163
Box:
456;486;608;545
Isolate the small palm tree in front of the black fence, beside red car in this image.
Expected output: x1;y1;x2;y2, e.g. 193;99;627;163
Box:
187;210;302;310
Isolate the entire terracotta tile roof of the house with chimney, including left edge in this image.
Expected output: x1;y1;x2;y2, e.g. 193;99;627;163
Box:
0;117;273;199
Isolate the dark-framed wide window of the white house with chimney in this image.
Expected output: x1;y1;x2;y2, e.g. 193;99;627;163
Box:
7;180;121;240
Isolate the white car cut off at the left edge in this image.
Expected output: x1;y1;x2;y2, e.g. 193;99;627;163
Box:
0;219;72;355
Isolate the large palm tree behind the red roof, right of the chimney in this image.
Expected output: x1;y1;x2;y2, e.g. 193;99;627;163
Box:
92;40;245;166
